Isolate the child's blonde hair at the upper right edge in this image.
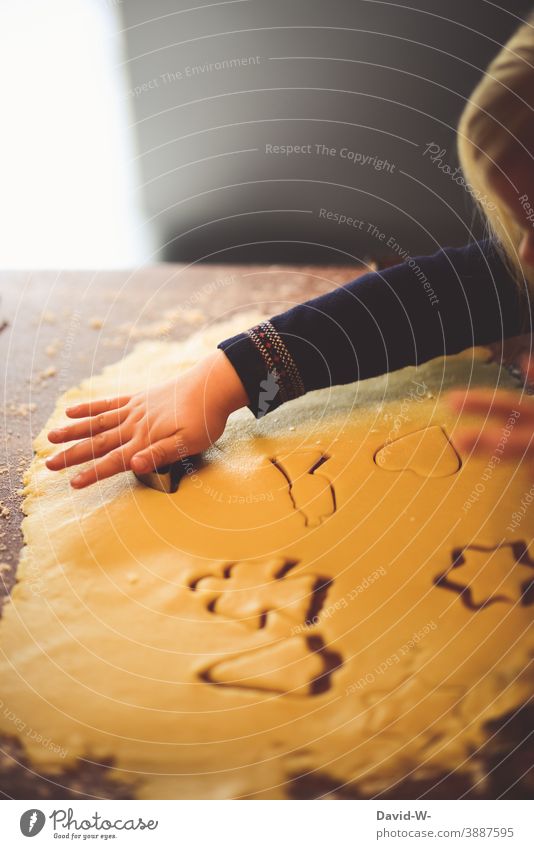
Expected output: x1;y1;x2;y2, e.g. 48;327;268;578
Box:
457;15;534;294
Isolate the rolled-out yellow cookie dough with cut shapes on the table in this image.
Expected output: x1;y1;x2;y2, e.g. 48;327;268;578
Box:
0;317;534;798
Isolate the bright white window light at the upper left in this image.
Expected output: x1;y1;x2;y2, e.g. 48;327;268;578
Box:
0;0;152;268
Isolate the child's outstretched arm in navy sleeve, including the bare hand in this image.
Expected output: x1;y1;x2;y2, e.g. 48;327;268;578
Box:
47;242;522;487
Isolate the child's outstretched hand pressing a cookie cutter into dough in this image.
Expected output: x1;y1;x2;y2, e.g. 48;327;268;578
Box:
46;350;248;489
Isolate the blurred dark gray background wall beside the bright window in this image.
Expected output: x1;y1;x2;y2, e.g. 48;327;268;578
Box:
121;0;532;263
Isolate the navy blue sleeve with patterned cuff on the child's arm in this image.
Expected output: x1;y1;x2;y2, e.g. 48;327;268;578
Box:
218;241;530;418
